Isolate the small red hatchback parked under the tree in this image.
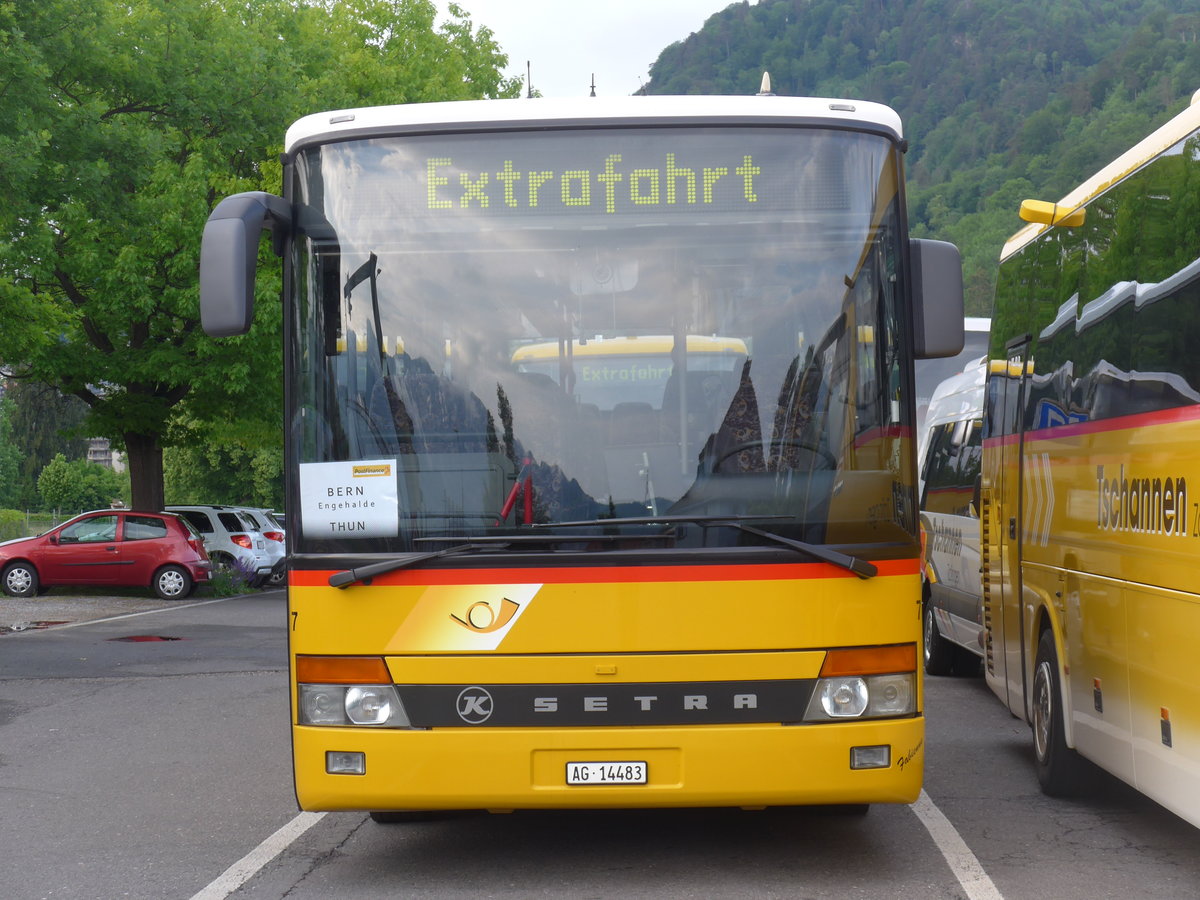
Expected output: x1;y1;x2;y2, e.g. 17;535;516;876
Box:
0;510;212;600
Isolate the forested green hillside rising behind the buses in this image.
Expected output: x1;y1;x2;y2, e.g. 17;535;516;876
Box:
647;0;1200;314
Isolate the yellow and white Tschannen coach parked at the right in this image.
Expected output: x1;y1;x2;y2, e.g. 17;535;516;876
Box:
982;90;1200;826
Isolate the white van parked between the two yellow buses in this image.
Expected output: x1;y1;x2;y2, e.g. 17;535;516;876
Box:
918;356;988;674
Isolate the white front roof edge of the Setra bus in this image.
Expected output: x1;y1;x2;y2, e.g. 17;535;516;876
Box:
284;95;904;154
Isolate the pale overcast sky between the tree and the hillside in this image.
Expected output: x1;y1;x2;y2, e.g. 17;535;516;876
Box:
438;0;733;97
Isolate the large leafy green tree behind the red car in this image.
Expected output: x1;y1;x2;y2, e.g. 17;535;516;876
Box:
0;0;520;509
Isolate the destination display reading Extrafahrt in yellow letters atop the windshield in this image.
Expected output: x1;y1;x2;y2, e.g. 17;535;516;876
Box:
296;128;894;230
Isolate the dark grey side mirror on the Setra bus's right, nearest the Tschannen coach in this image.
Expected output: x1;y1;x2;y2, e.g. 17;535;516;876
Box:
908;240;964;359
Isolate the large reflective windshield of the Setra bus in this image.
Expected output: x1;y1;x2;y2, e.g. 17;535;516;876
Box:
288;126;916;556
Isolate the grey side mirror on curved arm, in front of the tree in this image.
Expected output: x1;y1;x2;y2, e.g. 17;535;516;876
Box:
200;191;292;337
